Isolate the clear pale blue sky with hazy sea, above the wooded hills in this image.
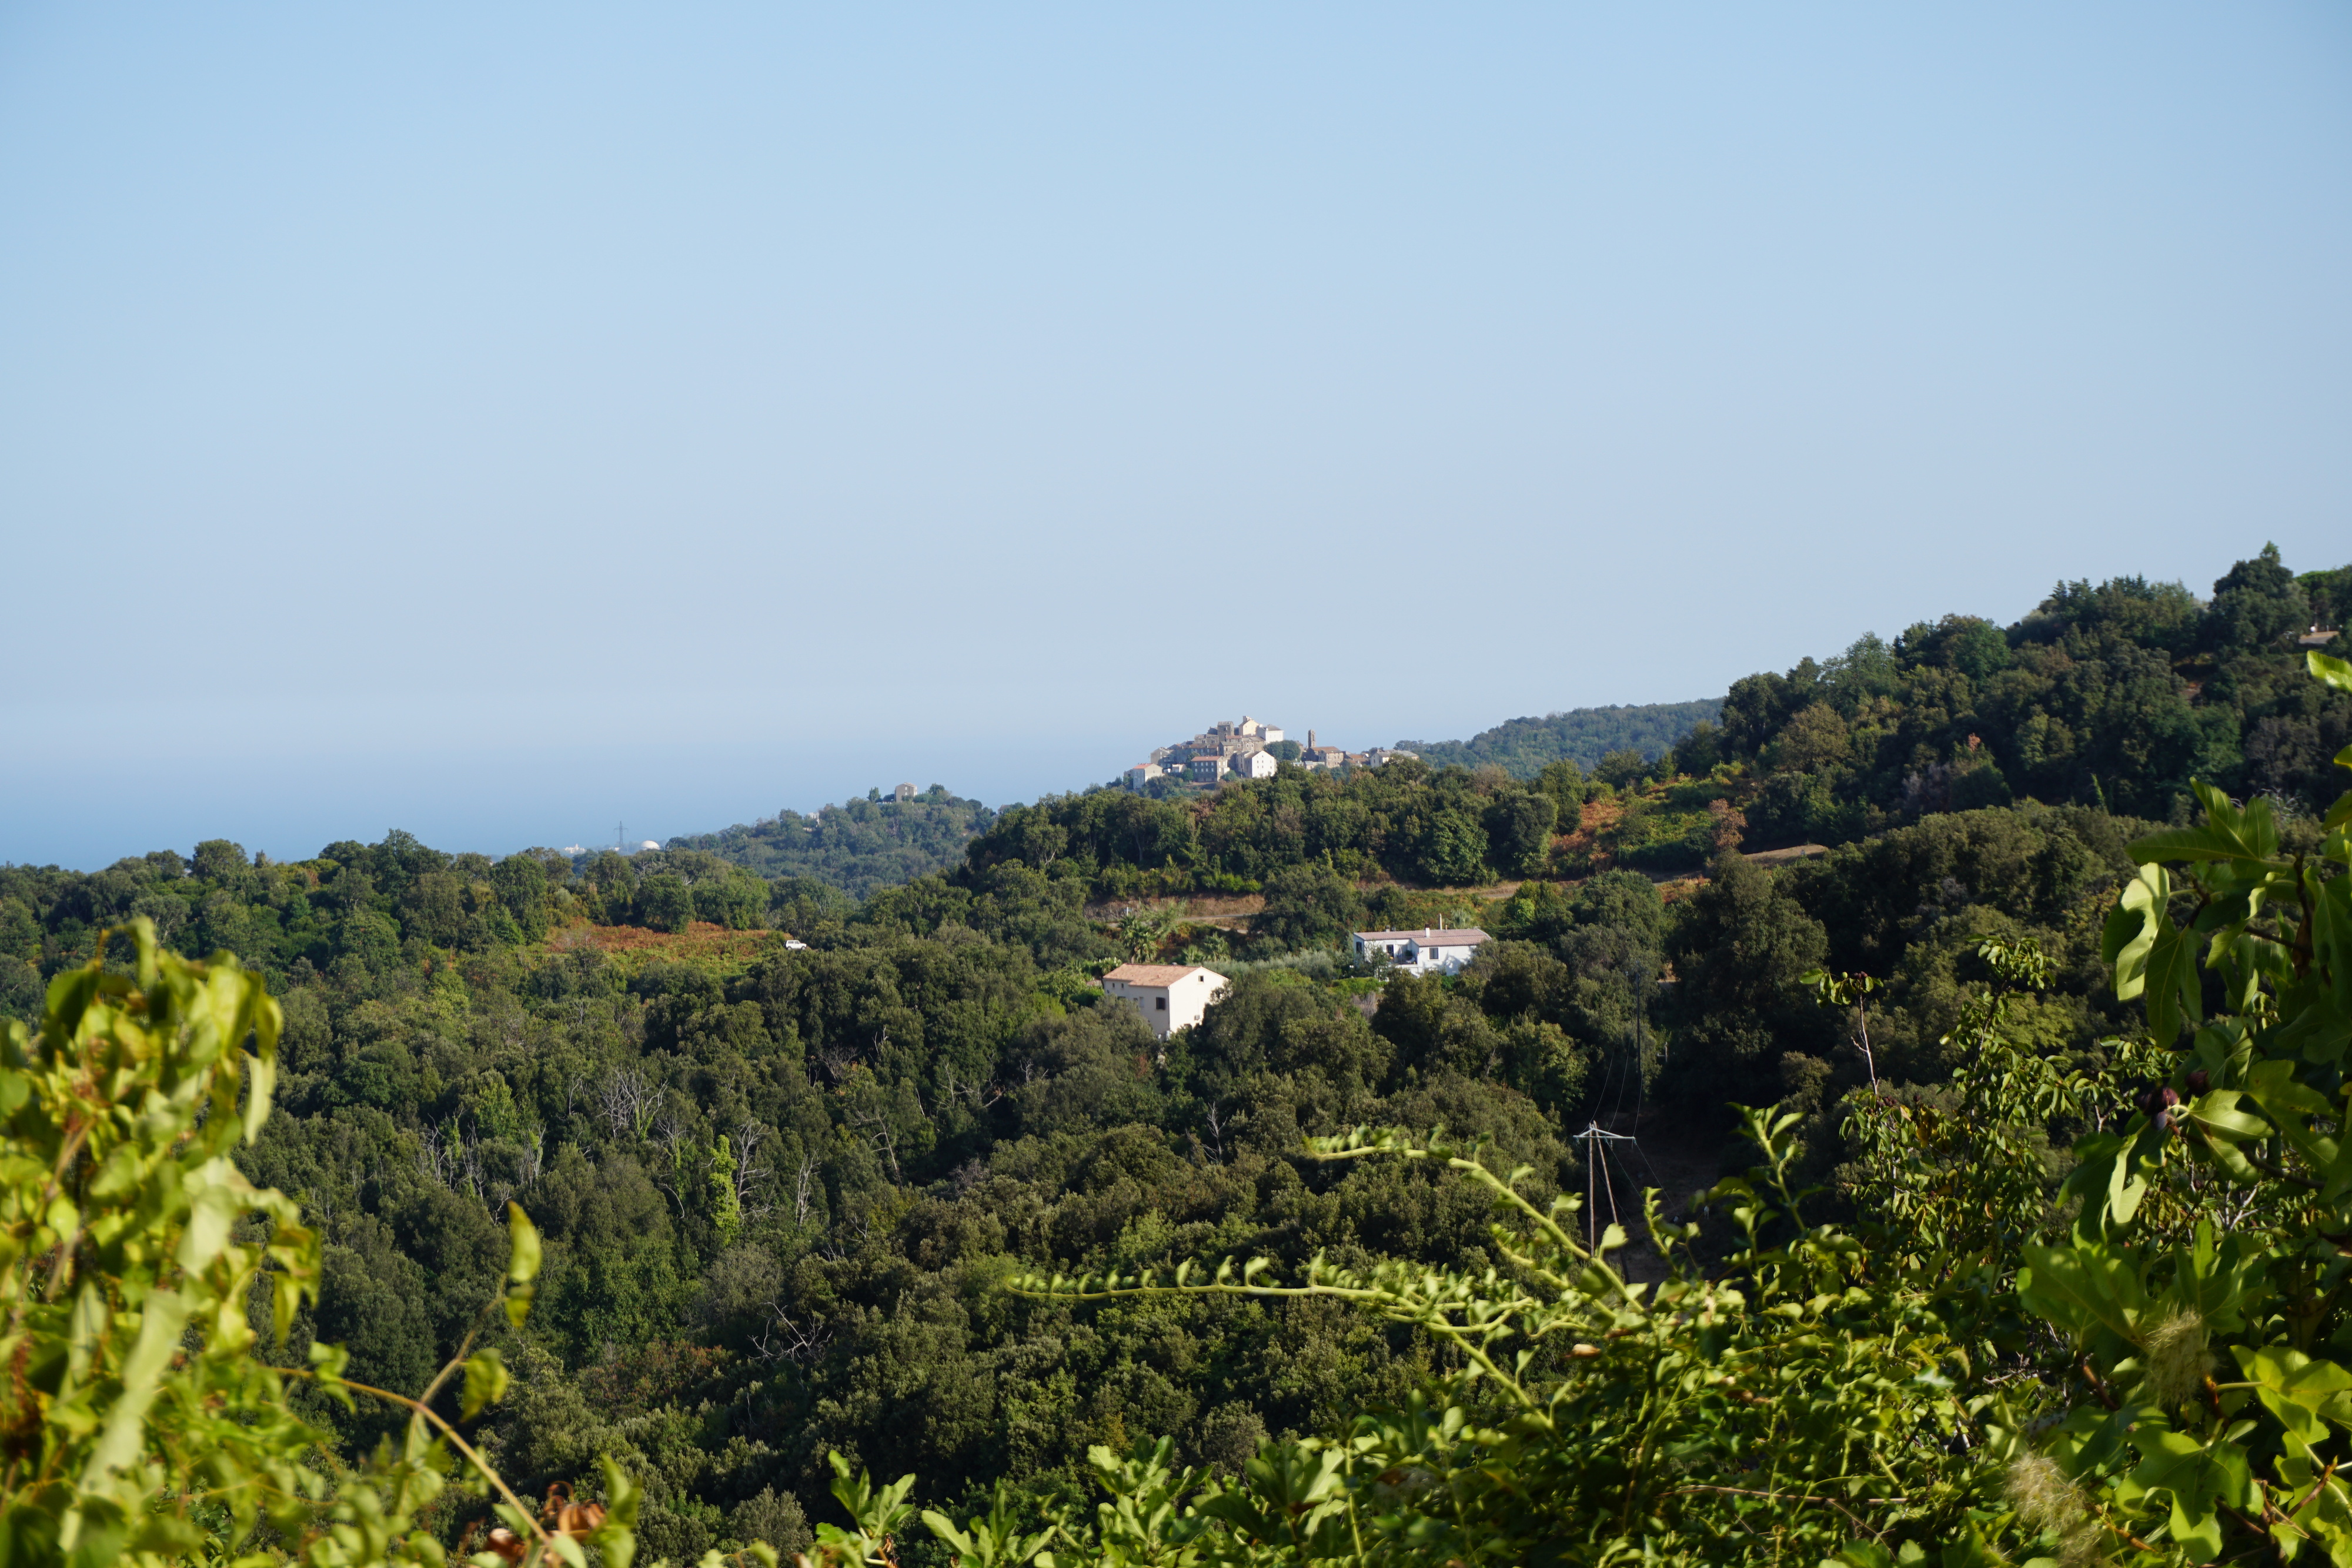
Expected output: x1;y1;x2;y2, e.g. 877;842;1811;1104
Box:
0;0;2352;867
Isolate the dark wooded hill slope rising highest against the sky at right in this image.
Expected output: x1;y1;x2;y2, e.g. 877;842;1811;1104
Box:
1712;548;2352;841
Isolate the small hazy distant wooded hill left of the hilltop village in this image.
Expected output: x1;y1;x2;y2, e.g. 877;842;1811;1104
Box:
668;785;995;898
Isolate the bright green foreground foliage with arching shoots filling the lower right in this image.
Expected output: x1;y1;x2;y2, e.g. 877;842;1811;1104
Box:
809;654;2352;1566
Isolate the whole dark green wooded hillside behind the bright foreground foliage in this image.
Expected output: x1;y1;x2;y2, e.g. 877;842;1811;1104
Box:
0;553;2352;1563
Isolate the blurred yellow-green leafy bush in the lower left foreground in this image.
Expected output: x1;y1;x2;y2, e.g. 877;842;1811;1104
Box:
0;921;635;1568
